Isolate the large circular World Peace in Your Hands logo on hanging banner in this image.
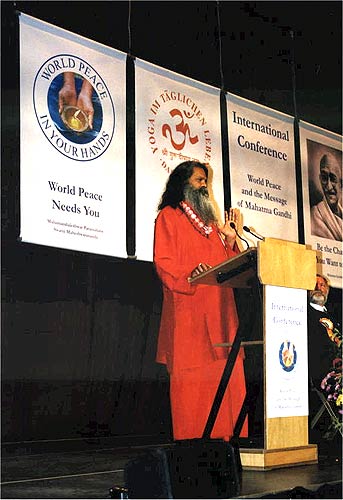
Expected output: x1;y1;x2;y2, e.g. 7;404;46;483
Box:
33;54;115;161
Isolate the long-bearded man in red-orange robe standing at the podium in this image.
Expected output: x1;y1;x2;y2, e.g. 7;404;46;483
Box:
154;161;247;440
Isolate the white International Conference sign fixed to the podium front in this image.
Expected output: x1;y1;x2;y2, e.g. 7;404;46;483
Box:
265;285;308;418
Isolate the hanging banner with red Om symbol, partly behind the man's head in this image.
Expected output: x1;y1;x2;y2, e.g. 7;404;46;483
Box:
135;59;224;261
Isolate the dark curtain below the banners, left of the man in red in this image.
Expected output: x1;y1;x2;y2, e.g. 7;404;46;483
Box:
2;240;170;442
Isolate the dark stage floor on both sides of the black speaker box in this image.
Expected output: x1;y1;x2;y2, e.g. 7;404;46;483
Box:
1;439;342;499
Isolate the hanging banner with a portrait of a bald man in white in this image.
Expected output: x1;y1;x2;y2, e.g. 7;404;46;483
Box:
299;122;342;288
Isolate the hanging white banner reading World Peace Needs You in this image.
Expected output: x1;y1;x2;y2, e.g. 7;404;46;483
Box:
19;14;126;257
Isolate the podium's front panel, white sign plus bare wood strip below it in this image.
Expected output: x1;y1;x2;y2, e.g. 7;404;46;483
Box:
264;285;308;448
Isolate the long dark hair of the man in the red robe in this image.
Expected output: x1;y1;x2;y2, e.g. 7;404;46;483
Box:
158;161;208;210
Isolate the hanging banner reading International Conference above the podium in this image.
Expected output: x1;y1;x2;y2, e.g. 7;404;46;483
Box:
227;94;298;245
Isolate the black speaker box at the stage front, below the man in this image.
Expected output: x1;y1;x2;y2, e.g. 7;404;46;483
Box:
124;439;242;498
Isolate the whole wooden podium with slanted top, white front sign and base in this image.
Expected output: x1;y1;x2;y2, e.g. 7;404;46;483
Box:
190;238;318;470
